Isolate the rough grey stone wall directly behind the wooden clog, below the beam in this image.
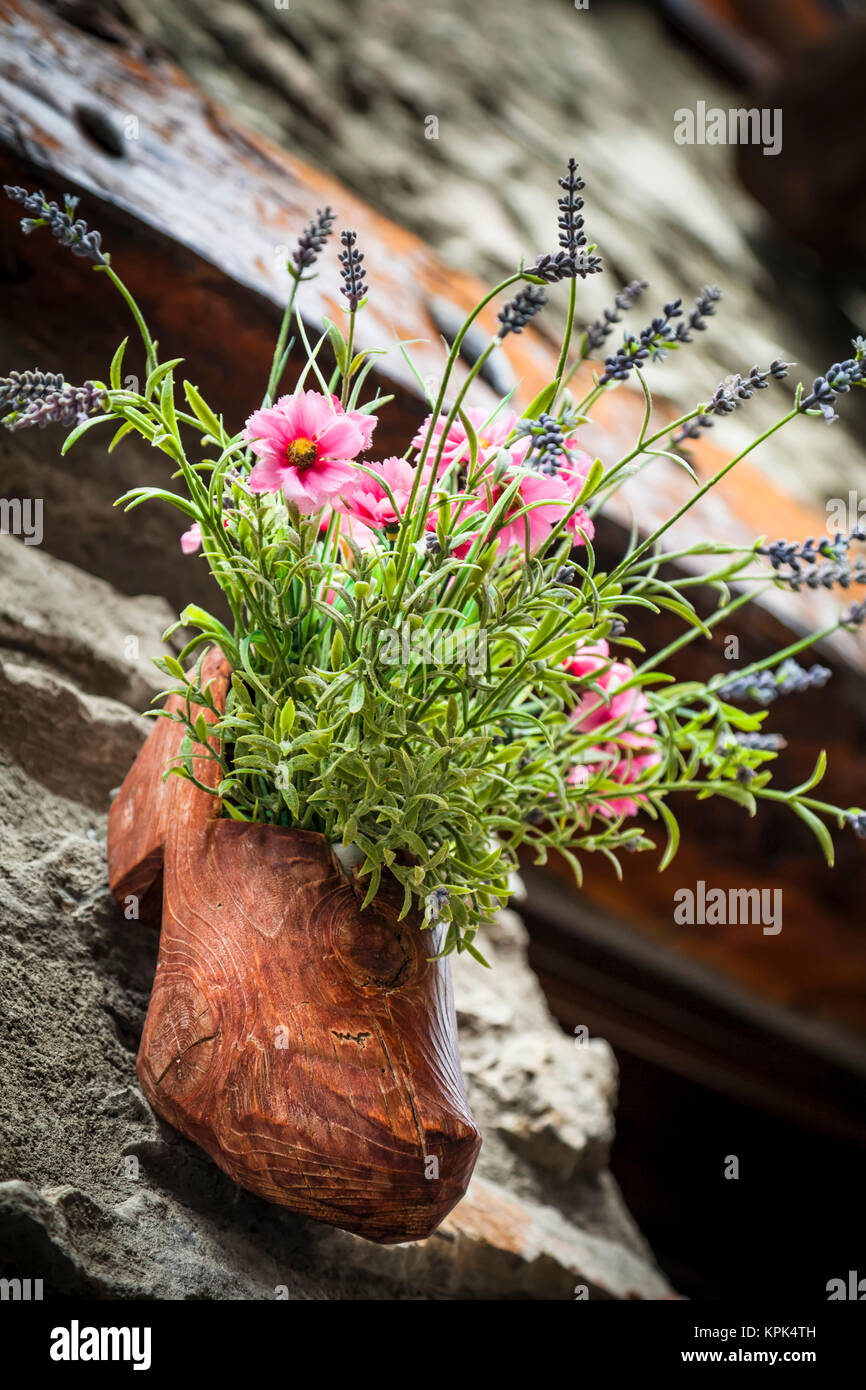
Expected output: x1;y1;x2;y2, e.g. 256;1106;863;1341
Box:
0;537;669;1298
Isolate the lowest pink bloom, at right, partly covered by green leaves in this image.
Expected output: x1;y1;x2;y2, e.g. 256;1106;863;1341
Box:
566;641;662;819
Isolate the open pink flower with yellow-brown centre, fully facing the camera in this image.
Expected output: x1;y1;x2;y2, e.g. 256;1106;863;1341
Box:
243;391;377;512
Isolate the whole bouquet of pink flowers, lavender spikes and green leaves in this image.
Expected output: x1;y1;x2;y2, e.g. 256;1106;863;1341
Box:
0;160;866;963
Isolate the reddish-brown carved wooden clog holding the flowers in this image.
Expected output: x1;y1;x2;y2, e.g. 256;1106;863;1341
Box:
108;653;481;1243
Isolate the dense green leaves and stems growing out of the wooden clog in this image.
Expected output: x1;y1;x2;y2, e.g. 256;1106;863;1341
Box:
18;173;859;960
